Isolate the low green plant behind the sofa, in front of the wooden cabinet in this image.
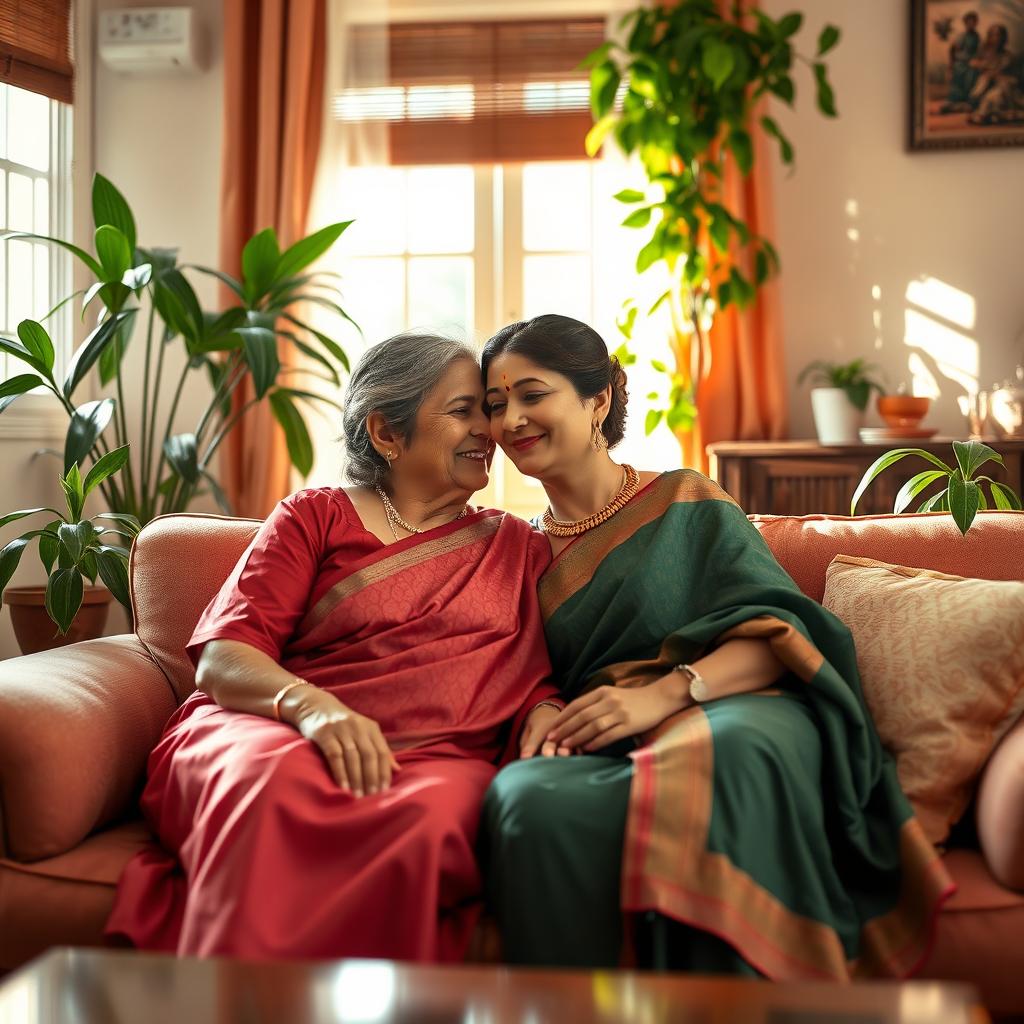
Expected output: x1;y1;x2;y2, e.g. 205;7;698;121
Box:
850;441;1021;534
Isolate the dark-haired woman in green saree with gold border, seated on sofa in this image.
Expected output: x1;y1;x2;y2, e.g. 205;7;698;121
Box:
482;315;953;980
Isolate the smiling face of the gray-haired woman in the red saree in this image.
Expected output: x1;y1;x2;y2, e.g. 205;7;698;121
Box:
392;358;494;498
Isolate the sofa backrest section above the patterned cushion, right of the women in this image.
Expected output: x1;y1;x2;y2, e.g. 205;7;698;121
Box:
750;511;1024;601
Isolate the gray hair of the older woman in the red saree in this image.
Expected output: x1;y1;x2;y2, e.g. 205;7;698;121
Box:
341;331;477;487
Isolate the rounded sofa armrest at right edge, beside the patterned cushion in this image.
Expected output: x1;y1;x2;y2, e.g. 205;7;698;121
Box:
978;716;1024;889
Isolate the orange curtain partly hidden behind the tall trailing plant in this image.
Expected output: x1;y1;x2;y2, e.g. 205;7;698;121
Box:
683;0;790;473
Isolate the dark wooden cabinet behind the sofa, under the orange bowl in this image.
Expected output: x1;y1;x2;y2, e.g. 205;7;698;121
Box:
708;437;1024;515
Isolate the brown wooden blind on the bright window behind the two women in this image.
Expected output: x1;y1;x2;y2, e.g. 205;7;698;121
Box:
334;18;605;165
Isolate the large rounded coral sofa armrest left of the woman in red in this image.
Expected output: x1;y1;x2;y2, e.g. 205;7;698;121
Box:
0;635;177;860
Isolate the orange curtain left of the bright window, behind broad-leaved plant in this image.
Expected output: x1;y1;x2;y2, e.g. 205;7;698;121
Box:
220;0;327;518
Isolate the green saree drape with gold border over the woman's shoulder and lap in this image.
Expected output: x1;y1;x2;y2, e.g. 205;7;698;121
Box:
540;470;953;980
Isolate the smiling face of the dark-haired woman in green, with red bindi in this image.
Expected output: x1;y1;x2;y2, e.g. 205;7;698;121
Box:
485;352;601;480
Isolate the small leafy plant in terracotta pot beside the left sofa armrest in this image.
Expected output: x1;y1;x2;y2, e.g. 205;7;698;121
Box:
0;446;139;654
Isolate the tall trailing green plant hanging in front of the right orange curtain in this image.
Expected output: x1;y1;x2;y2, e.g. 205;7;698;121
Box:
585;0;840;433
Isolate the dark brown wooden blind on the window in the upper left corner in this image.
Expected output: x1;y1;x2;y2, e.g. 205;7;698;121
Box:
0;0;75;103
